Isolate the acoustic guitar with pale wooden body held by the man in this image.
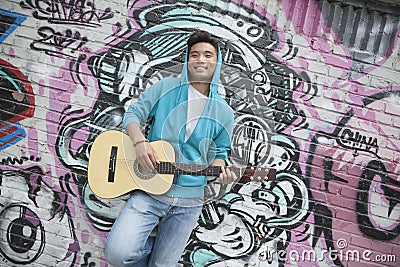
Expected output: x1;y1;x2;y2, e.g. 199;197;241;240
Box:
88;130;276;198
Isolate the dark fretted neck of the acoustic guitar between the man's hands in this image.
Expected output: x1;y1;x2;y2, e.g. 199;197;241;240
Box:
156;162;242;177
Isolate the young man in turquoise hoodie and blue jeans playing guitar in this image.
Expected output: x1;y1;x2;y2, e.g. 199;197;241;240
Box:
104;31;237;267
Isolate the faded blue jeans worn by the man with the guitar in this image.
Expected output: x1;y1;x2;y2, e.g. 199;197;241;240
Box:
104;190;202;267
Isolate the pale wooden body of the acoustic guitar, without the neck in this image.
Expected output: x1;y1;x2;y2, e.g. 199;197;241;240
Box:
88;130;175;198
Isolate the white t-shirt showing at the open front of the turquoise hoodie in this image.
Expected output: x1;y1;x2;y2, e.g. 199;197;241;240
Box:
185;84;208;142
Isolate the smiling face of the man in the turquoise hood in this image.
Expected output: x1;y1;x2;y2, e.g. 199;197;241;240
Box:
188;42;217;83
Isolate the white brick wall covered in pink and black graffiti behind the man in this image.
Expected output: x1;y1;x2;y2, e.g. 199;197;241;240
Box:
0;0;400;267
